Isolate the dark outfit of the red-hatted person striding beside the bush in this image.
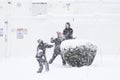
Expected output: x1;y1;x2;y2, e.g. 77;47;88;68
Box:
49;38;66;65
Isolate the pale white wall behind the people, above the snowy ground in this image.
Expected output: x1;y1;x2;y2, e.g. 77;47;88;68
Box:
0;0;120;57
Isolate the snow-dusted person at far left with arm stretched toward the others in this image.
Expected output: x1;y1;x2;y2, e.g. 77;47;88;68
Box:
36;39;53;73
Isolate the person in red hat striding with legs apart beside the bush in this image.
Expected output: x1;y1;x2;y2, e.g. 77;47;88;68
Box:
49;32;66;65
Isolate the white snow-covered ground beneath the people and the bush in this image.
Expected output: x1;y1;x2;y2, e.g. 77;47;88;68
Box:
0;55;120;80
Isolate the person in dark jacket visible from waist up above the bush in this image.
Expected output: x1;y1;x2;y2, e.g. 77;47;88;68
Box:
63;22;73;40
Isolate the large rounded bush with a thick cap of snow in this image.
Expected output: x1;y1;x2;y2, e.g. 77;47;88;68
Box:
61;39;97;67
